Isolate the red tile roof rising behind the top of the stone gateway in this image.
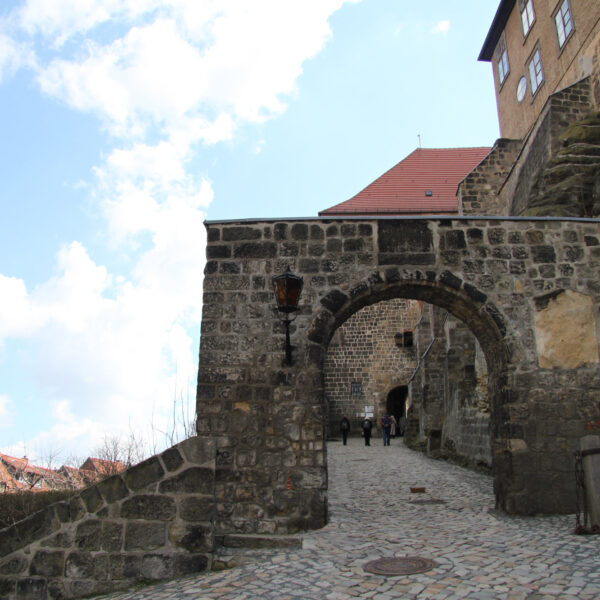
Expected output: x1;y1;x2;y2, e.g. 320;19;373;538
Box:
319;148;491;217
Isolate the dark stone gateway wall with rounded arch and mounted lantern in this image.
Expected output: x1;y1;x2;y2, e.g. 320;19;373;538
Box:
197;217;600;533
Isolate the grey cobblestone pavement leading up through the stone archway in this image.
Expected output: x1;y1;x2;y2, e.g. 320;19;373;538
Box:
99;439;600;600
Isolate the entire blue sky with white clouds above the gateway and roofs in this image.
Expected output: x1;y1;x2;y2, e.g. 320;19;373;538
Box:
0;0;499;464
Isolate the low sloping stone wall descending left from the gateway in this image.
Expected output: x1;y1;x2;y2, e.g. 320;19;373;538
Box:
0;438;216;600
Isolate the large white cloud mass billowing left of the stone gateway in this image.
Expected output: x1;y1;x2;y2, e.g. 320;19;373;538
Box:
0;0;356;455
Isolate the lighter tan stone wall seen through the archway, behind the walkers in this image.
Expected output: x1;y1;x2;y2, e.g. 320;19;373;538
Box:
323;298;421;436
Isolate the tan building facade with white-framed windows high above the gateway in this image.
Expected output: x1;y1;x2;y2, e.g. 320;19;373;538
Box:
479;0;600;139
